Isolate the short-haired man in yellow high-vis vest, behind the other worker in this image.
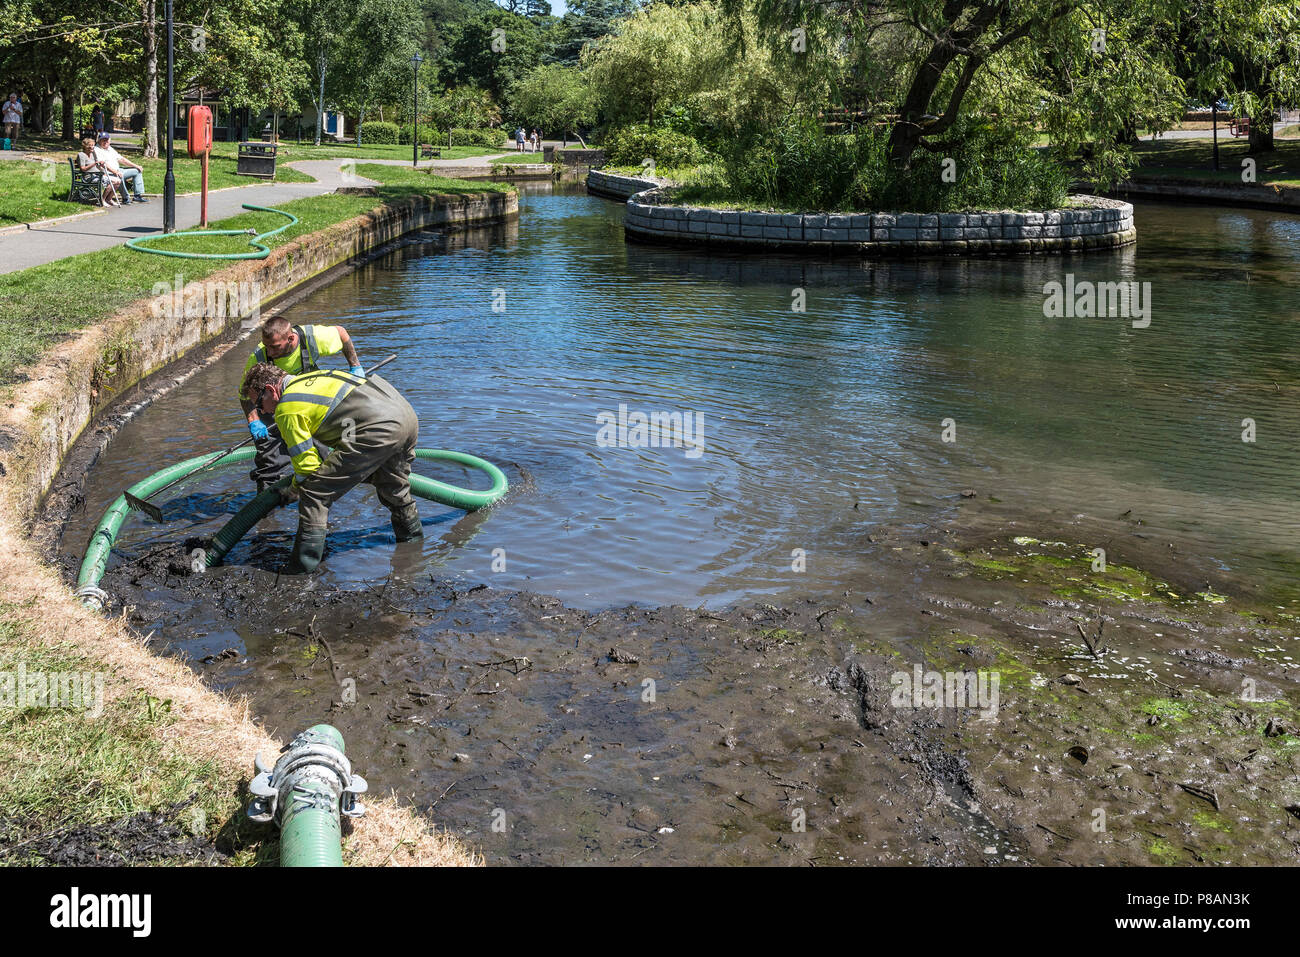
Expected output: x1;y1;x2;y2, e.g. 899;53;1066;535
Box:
239;316;365;492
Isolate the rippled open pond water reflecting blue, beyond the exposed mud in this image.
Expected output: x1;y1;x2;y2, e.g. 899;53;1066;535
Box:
66;184;1300;607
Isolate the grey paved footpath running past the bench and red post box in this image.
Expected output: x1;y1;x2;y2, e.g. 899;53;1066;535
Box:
0;153;508;273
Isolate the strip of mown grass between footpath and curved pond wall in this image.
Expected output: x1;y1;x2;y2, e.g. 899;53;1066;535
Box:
0;164;512;384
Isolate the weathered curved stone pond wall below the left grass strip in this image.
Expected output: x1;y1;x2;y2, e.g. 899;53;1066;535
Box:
0;184;519;528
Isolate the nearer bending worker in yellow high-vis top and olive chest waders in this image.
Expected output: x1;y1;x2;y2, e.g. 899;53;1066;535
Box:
243;363;424;572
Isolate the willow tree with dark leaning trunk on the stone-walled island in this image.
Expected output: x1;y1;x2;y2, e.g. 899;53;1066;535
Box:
723;0;1190;180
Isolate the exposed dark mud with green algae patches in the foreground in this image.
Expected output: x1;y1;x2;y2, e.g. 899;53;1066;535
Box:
78;488;1300;865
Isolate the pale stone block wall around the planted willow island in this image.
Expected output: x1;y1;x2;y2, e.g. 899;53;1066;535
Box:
624;187;1138;256
